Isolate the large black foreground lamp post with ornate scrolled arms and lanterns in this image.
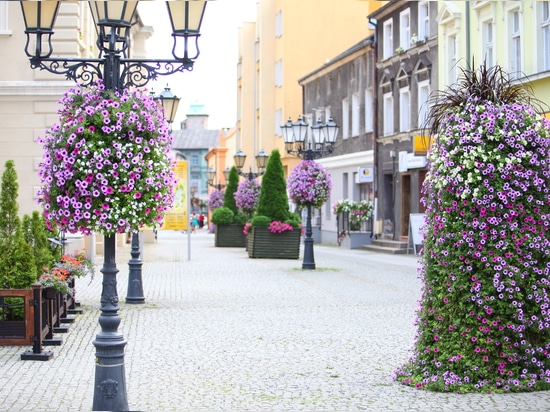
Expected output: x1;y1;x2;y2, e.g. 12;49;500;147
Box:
20;0;207;411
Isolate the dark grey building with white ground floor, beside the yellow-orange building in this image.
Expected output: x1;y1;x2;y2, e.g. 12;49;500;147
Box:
299;35;375;243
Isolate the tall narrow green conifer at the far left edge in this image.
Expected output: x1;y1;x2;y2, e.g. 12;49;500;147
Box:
0;160;21;242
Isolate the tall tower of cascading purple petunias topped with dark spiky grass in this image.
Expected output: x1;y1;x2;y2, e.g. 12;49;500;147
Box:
395;66;550;393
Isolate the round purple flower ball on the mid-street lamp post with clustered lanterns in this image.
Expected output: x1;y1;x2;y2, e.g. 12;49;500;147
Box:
287;160;332;208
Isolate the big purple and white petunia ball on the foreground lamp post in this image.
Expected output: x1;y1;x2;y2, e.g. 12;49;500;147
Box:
38;81;176;235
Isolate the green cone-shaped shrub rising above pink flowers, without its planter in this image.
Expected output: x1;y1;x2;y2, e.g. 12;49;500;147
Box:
256;149;290;222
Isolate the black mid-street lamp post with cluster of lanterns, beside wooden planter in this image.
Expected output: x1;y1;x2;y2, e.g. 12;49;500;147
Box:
281;117;339;269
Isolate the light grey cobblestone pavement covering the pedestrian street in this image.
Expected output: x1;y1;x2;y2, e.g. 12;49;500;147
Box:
0;231;550;411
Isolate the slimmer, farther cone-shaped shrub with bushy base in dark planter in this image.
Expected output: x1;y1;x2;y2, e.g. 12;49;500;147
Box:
212;166;246;247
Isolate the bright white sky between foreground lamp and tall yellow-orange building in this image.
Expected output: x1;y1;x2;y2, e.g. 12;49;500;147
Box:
138;0;257;130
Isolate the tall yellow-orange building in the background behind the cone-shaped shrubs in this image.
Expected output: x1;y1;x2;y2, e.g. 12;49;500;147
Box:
237;0;384;174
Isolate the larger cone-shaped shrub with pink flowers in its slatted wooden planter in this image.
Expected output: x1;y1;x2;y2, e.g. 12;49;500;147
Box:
246;149;301;259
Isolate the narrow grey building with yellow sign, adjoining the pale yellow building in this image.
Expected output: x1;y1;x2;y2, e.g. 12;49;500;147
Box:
369;1;438;240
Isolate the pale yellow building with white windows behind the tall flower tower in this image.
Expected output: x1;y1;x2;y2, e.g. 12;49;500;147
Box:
438;0;550;113
